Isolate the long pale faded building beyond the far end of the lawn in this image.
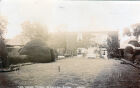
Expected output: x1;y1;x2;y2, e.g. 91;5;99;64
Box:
50;31;118;55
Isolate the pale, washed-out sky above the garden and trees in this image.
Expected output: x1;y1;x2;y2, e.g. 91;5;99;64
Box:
0;0;140;38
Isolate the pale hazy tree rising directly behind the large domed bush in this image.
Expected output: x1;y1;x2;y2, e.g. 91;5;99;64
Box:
22;21;48;41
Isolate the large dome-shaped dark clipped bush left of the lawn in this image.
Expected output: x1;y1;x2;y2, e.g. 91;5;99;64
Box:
20;40;57;63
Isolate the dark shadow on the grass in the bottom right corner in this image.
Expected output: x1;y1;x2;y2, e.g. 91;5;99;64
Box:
89;64;140;88
